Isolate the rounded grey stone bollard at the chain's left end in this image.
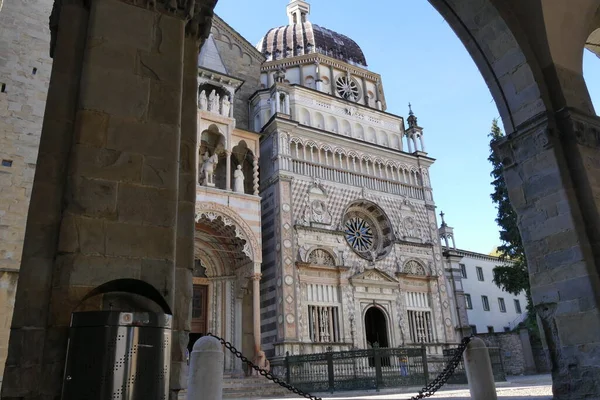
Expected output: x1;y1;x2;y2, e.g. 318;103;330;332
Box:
187;336;225;400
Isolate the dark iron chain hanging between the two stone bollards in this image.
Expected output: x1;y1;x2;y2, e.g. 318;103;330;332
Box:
207;333;473;400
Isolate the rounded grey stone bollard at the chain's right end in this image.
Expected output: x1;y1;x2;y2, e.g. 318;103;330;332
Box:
463;337;498;400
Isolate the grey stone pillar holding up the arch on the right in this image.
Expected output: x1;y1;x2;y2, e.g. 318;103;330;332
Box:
495;109;600;400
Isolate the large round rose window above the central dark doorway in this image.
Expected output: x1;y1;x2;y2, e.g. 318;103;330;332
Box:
343;200;394;261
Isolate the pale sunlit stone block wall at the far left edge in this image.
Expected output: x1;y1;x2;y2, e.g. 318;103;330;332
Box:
0;0;53;379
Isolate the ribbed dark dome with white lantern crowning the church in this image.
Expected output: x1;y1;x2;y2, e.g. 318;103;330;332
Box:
256;1;367;67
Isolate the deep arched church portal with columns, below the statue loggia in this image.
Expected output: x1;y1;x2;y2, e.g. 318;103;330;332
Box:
190;208;260;374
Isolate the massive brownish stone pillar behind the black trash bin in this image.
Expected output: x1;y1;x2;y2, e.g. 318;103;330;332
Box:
2;0;214;399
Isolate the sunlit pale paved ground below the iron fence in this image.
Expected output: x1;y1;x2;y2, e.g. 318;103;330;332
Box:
231;375;552;400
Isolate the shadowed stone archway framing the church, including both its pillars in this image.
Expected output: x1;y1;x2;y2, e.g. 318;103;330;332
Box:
2;0;600;399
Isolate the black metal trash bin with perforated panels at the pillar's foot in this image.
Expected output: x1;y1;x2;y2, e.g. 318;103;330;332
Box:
62;280;172;400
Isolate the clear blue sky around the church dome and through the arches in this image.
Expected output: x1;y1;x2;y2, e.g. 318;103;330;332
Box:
215;0;600;253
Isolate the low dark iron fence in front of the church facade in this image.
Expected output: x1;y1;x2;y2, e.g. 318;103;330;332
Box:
271;346;506;393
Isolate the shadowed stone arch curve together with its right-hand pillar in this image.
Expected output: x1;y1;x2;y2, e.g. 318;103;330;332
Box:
429;0;600;399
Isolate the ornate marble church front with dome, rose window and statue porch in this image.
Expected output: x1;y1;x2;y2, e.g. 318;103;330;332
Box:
192;0;461;362
